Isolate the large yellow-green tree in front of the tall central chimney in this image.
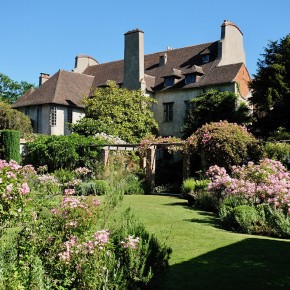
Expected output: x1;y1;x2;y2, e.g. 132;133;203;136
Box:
70;81;157;143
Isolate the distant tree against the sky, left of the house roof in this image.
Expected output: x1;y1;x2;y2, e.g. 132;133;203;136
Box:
0;73;34;104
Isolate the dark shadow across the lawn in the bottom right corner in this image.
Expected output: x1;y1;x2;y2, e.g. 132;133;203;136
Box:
152;238;290;290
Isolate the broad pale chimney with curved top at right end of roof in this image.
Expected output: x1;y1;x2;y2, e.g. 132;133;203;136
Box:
218;20;246;66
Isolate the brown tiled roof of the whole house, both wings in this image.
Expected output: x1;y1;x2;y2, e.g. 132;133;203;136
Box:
13;41;243;108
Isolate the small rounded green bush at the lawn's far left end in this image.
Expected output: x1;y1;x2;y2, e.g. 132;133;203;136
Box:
76;180;110;195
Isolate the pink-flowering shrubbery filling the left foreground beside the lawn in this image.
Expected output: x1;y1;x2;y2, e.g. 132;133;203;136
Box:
0;160;170;290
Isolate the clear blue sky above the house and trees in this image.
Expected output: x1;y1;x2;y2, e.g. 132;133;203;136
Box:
0;0;290;85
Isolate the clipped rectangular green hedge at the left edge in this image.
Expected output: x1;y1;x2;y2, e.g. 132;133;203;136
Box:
0;130;20;163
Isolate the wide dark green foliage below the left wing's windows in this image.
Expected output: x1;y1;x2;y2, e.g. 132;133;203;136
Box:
23;134;104;172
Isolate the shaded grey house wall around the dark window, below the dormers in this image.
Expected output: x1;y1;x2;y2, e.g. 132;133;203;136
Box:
152;83;237;137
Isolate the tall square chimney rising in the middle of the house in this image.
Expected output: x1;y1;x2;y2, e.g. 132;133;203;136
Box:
123;29;144;90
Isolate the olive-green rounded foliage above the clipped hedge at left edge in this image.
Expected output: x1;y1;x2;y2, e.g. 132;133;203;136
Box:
0;100;32;133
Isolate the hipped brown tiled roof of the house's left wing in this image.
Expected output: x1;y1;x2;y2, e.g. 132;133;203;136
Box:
12;70;94;108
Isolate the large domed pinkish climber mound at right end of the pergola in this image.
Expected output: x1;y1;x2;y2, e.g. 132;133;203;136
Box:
188;121;259;170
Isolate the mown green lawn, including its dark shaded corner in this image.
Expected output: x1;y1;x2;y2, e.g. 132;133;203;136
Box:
117;195;290;290
